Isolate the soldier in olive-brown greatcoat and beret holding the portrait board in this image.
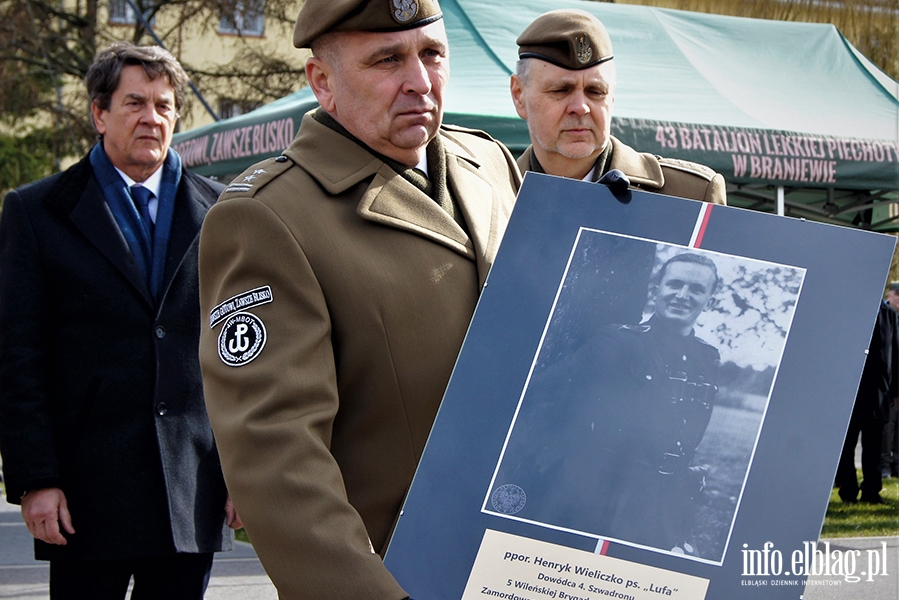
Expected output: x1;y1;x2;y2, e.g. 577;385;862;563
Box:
200;0;521;600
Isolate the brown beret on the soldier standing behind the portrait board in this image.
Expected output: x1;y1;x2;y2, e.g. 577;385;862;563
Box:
516;9;613;70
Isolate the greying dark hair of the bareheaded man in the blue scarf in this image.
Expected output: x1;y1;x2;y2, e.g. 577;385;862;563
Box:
84;42;189;111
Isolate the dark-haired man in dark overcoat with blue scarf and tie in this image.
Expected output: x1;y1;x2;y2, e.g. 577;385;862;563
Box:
0;43;240;600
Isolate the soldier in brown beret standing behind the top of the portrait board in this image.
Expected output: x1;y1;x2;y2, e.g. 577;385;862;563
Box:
510;9;725;204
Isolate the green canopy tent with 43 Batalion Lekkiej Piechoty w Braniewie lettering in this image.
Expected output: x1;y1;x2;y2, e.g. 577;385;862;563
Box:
174;0;898;231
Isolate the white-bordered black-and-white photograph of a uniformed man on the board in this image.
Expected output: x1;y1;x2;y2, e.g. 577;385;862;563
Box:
483;228;805;564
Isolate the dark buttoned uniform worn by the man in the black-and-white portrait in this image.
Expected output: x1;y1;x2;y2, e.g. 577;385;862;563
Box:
580;317;719;553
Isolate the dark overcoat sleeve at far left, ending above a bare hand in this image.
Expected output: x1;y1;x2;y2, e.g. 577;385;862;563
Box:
0;191;60;504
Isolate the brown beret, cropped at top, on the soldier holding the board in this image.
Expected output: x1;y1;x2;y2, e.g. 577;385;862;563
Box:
294;0;443;48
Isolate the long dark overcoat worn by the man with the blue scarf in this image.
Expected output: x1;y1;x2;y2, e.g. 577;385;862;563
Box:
0;151;232;560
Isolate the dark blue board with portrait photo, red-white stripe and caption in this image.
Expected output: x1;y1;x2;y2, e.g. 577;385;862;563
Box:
385;173;895;600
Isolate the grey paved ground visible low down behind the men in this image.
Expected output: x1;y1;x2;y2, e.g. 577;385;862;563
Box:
0;490;900;600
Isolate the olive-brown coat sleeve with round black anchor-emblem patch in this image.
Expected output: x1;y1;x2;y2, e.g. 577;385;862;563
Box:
200;198;407;600
